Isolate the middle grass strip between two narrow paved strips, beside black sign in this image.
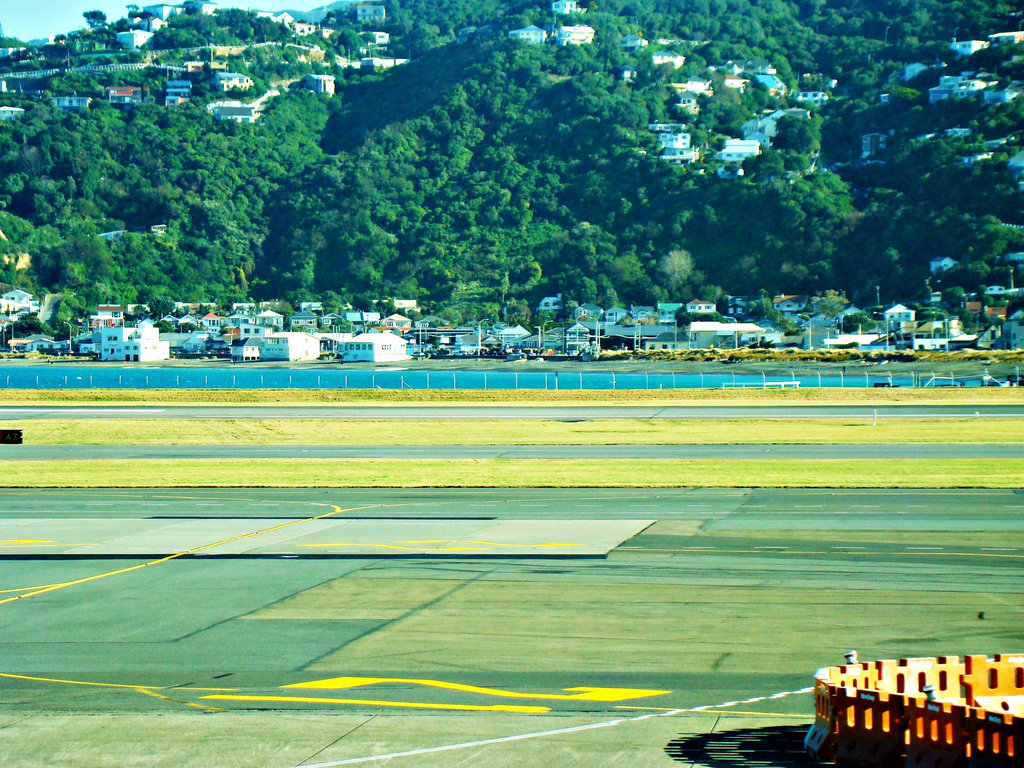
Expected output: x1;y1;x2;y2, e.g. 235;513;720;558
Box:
8;416;1024;445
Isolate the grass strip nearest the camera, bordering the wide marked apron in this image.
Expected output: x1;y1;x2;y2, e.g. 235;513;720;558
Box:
4;459;1024;488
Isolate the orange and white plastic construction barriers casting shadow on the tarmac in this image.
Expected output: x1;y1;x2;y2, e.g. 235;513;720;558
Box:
804;651;1024;768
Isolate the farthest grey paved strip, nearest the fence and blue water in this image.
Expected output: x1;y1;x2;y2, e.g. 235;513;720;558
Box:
0;403;1024;423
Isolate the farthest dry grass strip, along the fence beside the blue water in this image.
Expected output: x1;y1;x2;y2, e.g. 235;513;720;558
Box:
2;387;1024;406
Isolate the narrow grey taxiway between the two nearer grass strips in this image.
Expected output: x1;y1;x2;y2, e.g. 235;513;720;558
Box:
0;443;1024;461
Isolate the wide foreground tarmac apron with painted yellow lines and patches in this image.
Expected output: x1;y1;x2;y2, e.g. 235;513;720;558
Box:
0;488;1024;768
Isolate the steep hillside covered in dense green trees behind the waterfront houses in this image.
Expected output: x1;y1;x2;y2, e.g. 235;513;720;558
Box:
0;0;1024;319
